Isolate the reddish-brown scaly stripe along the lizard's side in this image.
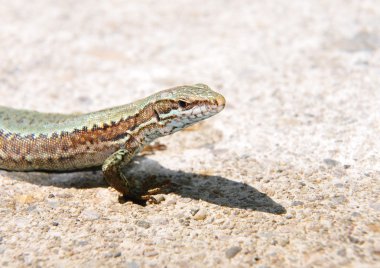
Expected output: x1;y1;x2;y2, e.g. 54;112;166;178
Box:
0;100;176;170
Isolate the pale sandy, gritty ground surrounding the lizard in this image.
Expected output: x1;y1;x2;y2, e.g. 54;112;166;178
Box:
0;0;380;268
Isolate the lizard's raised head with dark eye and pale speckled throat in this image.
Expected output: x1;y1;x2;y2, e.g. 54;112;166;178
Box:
146;84;226;138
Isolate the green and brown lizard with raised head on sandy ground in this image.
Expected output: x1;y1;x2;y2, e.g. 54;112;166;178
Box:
0;84;225;200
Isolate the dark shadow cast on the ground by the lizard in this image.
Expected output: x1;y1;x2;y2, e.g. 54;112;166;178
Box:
5;157;286;214
